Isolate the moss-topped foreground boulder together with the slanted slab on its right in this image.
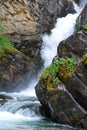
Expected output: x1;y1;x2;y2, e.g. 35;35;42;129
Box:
35;55;87;128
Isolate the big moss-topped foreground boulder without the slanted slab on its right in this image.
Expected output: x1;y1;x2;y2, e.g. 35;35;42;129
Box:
36;57;85;126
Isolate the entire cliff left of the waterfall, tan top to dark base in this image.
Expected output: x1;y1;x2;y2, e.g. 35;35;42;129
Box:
0;0;74;90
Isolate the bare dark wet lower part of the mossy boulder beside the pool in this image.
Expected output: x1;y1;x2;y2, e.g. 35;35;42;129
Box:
36;84;85;126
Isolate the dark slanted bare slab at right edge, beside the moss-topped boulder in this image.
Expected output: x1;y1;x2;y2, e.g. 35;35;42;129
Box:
66;61;87;110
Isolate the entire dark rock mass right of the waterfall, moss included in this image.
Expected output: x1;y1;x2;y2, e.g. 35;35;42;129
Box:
35;2;87;129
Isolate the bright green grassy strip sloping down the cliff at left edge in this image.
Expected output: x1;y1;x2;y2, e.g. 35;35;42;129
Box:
0;14;31;60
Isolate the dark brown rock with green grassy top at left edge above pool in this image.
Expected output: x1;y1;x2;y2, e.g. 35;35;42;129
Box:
0;35;31;91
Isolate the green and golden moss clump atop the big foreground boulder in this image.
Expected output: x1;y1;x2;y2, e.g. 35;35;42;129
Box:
40;57;76;90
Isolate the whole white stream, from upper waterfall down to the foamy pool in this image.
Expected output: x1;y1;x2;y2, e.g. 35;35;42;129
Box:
0;0;87;130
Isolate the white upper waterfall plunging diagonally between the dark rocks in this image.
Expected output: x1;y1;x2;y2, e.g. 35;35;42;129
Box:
41;0;87;67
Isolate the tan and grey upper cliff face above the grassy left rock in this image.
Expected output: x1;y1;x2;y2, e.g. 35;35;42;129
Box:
2;0;75;59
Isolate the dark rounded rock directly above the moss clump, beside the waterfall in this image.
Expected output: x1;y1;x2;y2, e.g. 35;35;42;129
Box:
57;31;87;59
